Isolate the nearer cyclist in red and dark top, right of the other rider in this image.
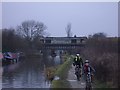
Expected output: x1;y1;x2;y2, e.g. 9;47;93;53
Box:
83;60;95;82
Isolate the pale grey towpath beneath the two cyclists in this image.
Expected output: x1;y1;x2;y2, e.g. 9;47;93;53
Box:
67;65;85;90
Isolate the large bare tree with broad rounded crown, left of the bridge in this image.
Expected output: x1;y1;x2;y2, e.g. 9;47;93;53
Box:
17;20;47;41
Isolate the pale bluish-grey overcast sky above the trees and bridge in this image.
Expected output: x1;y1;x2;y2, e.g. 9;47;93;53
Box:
2;2;118;36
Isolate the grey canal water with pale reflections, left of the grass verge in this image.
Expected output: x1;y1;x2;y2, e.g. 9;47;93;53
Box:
2;56;61;88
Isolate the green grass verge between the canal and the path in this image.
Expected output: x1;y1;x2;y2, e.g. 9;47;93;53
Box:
51;57;72;89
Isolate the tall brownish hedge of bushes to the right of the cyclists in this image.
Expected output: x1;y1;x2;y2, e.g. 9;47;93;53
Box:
82;33;120;87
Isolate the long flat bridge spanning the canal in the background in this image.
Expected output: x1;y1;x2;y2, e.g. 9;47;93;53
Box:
40;37;87;50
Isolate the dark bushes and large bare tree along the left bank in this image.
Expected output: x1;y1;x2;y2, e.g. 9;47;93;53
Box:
2;20;47;52
